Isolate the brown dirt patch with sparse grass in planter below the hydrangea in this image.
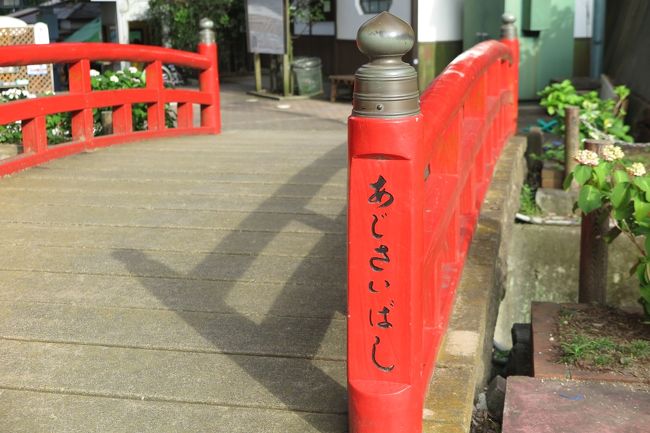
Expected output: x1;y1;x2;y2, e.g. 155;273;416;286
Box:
555;305;650;383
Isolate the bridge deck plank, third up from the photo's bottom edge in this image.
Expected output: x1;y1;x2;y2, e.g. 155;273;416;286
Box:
0;302;346;361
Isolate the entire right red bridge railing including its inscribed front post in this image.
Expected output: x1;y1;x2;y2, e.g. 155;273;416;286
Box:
348;13;518;433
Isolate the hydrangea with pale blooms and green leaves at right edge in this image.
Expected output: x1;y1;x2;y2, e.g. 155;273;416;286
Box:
564;145;650;318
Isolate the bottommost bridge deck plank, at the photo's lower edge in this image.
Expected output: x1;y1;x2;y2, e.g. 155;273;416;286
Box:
0;389;347;433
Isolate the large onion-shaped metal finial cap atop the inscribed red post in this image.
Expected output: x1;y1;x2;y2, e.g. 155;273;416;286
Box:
352;12;420;117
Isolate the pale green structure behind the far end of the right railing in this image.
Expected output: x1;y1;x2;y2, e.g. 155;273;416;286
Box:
463;0;575;100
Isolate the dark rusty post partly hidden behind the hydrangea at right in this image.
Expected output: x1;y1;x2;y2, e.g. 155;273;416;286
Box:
578;140;609;304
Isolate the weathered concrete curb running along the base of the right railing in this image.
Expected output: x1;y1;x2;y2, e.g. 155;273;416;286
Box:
423;137;526;433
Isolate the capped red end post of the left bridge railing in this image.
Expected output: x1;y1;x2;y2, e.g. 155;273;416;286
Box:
198;18;221;134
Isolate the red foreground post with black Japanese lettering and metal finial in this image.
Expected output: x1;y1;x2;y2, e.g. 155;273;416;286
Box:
348;12;427;433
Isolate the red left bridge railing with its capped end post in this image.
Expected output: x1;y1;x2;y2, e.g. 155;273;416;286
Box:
0;16;221;176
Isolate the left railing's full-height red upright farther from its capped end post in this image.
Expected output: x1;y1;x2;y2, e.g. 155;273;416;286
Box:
68;59;94;145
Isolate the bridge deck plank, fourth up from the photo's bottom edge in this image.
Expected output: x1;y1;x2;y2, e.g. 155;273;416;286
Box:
0;271;346;319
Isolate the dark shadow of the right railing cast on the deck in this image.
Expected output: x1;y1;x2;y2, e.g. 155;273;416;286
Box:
113;143;347;432
